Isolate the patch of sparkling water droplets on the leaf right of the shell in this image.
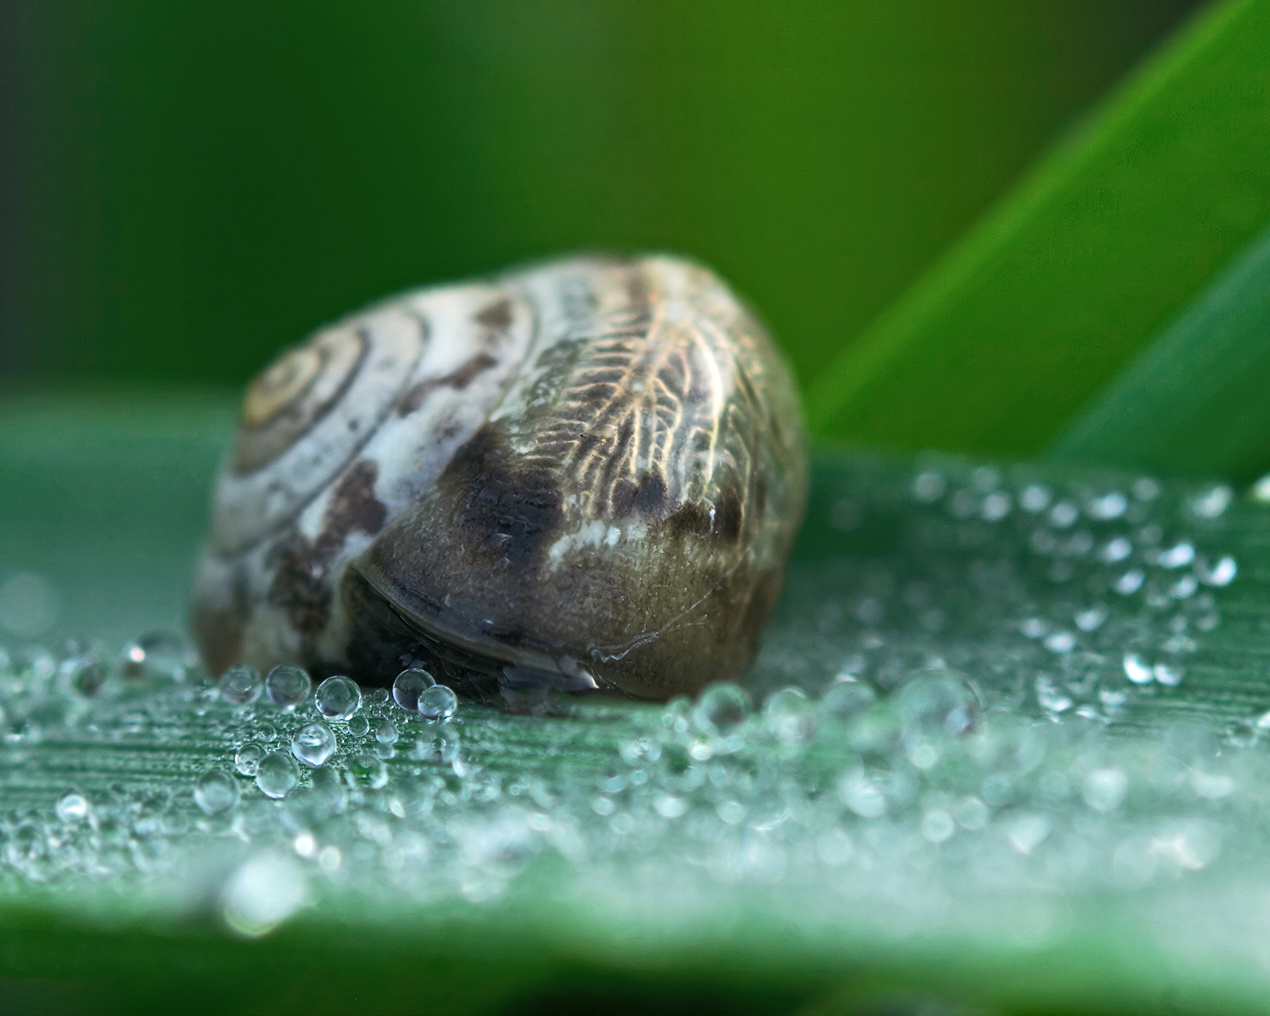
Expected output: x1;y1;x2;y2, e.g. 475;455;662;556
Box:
761;462;1238;720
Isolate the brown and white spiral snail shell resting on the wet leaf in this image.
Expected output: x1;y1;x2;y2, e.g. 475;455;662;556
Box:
193;257;806;699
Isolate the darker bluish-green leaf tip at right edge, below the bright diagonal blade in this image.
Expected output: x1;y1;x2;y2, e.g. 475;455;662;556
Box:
1048;219;1270;481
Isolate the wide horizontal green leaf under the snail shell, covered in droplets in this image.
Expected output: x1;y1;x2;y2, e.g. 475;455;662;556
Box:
0;395;1270;1013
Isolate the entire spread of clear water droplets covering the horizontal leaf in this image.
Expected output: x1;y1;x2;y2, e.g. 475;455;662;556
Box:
0;454;1270;935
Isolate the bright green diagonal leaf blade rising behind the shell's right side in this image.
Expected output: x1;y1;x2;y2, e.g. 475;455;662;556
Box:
808;0;1270;465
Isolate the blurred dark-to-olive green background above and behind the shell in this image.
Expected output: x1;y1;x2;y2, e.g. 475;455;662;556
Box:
0;0;1196;401
